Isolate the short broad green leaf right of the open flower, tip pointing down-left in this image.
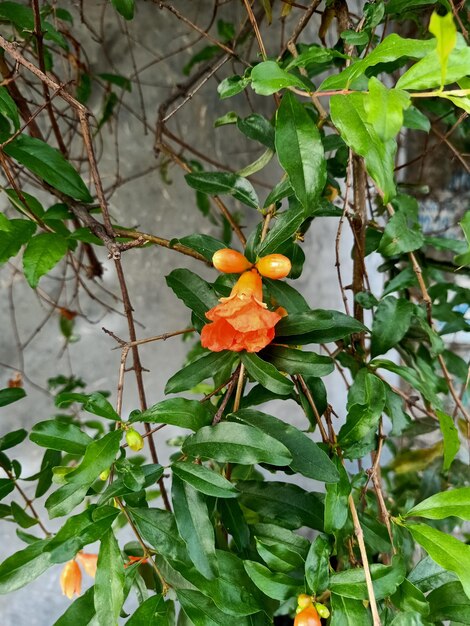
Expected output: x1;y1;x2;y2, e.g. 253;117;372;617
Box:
371;296;414;357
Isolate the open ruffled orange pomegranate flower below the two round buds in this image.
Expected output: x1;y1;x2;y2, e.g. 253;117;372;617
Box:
201;269;282;352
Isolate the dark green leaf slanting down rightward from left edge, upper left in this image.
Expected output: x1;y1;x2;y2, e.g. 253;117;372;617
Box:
3;134;93;202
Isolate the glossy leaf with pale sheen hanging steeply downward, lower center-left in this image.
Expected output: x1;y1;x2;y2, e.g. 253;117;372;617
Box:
171;474;219;579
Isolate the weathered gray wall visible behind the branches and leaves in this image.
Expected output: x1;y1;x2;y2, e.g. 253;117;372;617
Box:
0;0;380;626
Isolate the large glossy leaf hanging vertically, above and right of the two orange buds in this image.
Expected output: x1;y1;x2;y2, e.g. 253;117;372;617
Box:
276;92;326;214
